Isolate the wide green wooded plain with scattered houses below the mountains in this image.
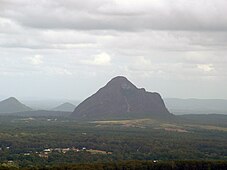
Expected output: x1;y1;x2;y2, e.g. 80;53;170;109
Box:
0;116;227;169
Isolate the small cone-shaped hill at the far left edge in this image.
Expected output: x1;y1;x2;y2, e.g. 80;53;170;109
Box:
0;97;32;113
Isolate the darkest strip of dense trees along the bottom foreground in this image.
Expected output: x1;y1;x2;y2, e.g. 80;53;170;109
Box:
0;161;227;170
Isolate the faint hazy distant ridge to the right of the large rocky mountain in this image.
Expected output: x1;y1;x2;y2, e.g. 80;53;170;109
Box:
164;98;227;115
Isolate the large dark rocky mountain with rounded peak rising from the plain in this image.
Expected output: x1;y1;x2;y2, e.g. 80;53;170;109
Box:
72;76;172;120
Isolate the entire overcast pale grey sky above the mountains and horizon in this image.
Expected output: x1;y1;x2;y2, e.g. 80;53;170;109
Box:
0;0;227;99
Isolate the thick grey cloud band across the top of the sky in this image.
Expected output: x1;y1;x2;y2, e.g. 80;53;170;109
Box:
1;0;227;31
